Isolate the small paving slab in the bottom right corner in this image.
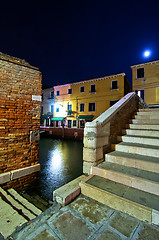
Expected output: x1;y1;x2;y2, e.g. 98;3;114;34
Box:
138;225;159;240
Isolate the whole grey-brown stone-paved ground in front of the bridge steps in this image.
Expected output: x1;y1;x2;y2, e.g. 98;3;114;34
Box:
4;195;159;240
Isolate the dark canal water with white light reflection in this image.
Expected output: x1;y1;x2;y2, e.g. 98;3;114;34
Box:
38;138;83;200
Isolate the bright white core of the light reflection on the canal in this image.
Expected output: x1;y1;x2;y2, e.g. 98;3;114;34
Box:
49;148;63;172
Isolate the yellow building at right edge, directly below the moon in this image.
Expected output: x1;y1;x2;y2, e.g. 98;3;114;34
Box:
131;60;159;106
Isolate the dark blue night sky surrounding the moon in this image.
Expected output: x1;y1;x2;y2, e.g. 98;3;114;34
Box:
0;0;159;86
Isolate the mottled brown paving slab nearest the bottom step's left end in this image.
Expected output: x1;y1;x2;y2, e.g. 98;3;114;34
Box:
72;198;113;223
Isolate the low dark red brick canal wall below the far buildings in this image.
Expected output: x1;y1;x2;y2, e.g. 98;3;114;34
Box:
40;127;84;140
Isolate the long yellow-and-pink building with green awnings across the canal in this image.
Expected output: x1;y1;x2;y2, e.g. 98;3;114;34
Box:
53;73;131;128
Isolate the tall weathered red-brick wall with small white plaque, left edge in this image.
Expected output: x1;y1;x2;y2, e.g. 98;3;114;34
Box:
0;53;42;189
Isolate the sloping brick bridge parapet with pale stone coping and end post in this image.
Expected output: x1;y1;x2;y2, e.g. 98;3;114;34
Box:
83;92;139;174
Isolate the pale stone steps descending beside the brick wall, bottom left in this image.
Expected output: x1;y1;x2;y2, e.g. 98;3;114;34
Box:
0;187;42;238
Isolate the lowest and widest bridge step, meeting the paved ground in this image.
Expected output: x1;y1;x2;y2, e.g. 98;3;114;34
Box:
80;175;159;224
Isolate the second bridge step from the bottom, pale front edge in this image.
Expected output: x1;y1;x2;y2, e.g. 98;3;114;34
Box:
92;162;159;195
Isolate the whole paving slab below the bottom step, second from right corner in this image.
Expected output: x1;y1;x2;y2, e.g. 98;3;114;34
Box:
109;213;138;237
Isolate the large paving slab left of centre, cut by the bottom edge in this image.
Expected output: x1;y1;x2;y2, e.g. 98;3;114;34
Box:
53;211;91;240
